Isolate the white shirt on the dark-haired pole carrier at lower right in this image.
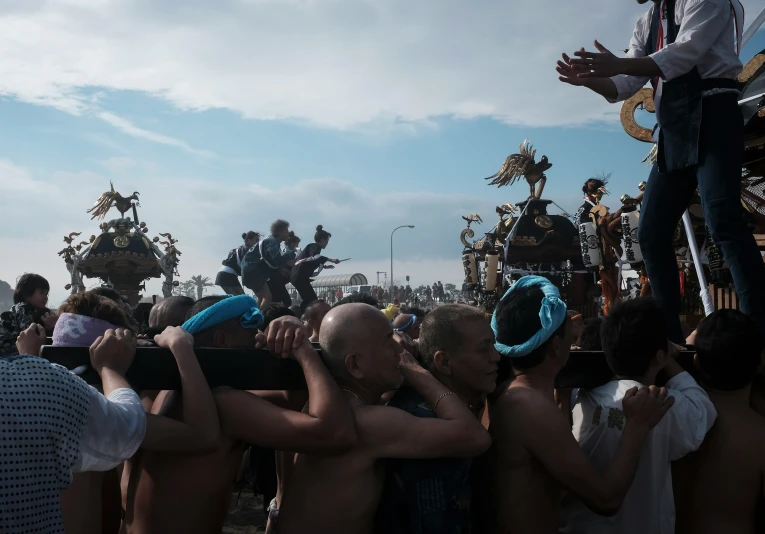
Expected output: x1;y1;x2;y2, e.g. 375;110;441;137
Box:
560;372;717;534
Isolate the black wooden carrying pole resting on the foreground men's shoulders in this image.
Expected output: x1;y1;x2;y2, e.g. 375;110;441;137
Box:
40;345;694;391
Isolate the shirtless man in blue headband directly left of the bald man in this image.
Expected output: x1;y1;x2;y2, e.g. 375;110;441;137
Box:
123;295;357;534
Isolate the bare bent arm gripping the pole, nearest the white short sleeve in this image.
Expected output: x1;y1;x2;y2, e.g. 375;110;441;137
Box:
141;326;220;451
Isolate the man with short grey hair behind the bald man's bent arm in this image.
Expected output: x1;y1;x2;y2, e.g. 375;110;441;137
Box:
375;304;500;534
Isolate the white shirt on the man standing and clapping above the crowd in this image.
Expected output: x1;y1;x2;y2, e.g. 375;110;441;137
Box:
609;0;743;103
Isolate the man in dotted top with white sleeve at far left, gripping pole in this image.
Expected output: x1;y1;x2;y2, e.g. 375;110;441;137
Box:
0;325;146;534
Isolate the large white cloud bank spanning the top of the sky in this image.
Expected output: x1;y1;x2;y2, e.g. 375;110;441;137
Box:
0;0;765;130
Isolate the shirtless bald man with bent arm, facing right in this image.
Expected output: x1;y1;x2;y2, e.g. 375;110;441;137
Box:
276;304;491;534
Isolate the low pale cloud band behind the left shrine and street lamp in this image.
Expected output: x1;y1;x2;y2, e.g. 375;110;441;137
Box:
0;160;494;303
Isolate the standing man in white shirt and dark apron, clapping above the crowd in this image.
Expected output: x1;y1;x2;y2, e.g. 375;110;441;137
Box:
557;0;765;343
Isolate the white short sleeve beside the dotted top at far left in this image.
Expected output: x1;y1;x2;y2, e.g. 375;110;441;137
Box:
72;386;146;473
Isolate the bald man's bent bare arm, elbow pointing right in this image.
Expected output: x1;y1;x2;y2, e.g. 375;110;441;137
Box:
357;353;491;458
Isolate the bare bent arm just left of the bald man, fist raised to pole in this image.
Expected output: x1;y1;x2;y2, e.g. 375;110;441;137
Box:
215;340;357;453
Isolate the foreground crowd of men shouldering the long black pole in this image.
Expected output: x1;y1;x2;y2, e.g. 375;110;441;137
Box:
0;264;765;534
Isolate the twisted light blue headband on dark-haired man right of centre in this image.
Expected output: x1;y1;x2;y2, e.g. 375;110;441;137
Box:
491;276;566;358
